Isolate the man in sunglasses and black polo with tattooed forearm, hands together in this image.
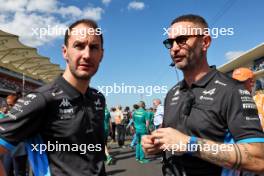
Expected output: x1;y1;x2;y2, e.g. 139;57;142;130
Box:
142;15;264;176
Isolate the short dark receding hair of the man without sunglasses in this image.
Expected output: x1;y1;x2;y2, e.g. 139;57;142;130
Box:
64;19;104;48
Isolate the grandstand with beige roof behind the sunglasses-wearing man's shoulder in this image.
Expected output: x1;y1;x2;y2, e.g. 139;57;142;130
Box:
218;43;264;89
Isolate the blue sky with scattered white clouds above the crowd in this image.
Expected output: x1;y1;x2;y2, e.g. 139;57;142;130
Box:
0;0;264;107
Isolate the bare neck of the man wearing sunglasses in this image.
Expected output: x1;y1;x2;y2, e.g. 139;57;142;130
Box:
183;62;210;86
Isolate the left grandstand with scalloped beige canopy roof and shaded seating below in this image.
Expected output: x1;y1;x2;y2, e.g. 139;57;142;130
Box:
0;30;63;100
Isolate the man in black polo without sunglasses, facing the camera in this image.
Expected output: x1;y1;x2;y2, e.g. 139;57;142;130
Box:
0;19;106;176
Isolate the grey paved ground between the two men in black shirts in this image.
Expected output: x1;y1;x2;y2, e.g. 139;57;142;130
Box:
106;144;162;176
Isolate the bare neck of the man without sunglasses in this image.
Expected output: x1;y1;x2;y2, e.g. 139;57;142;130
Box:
62;72;90;94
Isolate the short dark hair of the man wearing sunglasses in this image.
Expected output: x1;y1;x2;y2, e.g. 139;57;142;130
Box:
171;14;208;28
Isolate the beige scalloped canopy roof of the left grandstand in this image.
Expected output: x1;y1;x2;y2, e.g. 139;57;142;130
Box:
0;30;63;82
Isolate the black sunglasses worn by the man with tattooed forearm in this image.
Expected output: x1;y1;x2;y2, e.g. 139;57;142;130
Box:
163;35;203;49
